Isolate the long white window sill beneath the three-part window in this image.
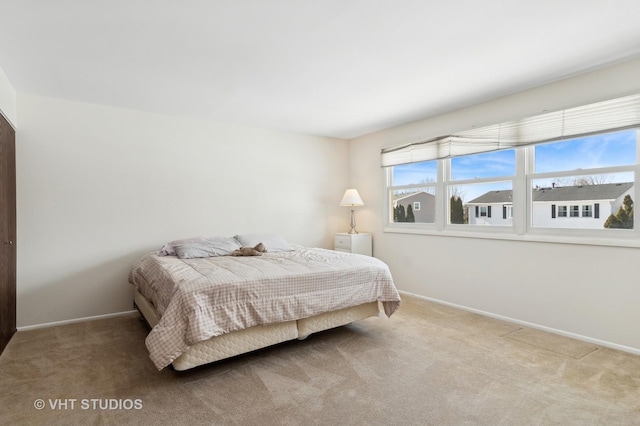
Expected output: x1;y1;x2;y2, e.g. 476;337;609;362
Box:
383;225;640;248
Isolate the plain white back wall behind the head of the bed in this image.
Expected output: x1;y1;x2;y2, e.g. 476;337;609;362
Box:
16;94;348;327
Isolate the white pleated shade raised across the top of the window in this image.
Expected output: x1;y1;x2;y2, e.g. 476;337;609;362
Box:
382;94;640;167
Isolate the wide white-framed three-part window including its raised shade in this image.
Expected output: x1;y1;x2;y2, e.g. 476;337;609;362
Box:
382;95;640;245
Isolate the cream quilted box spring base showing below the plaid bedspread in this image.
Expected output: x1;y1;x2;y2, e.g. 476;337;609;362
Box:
134;289;380;371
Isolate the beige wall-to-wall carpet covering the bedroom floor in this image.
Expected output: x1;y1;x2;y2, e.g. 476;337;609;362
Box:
0;297;640;426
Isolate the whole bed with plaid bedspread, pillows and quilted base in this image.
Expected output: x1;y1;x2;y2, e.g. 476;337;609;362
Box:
129;234;401;371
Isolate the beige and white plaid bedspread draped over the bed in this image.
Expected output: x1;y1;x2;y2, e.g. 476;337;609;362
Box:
129;248;400;369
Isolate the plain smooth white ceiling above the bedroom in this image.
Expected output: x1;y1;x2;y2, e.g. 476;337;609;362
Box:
0;0;640;138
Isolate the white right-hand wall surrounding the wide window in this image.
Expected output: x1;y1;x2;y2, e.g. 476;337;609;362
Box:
350;59;640;351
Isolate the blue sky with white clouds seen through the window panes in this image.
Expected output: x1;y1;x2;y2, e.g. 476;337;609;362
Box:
393;130;638;202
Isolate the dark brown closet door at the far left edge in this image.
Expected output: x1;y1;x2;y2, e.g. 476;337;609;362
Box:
0;114;16;353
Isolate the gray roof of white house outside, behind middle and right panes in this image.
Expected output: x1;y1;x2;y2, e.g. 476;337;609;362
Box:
467;182;633;204
